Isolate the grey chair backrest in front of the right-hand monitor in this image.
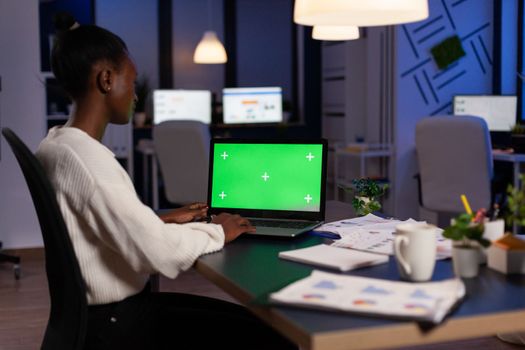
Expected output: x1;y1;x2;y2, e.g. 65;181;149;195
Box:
416;116;493;226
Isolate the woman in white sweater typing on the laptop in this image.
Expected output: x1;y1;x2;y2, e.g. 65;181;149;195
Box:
37;14;291;349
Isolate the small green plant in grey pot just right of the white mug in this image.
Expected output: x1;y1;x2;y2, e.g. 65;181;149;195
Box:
443;214;490;278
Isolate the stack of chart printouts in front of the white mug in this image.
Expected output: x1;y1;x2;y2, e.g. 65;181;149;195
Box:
270;271;465;324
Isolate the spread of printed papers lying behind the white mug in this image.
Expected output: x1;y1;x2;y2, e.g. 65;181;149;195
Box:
316;214;452;260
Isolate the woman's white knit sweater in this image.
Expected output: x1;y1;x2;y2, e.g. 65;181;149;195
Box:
37;127;224;304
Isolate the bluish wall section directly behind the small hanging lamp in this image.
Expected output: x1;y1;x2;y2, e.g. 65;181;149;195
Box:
172;0;224;98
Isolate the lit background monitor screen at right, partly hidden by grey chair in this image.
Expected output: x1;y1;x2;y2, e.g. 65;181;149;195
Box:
454;95;517;131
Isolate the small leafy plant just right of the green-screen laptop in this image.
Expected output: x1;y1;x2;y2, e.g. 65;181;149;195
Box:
344;178;388;216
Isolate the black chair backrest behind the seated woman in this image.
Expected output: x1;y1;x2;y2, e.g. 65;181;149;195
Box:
2;128;88;350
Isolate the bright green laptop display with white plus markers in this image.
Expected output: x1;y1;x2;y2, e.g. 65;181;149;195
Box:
208;141;325;212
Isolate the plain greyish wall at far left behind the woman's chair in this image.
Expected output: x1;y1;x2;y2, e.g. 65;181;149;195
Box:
0;0;45;248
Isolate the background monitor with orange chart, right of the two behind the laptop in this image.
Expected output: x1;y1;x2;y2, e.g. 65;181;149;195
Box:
222;87;283;124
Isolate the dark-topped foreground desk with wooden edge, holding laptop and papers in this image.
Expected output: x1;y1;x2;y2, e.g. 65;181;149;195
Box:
195;201;525;350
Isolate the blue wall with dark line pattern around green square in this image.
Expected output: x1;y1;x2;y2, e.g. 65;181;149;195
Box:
393;0;494;218
